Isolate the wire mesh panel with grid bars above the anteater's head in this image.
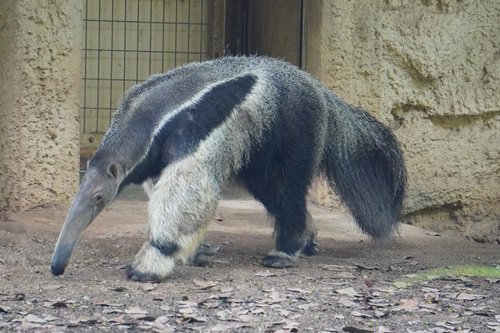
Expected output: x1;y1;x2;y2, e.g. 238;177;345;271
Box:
80;0;211;162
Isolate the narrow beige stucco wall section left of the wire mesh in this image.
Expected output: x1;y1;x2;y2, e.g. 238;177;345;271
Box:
0;0;81;218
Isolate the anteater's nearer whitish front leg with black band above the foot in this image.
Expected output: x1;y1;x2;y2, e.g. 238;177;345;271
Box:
127;163;219;281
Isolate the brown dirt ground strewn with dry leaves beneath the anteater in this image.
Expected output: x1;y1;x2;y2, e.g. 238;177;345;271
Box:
0;185;500;333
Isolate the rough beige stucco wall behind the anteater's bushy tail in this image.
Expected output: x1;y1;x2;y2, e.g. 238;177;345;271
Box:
308;0;500;243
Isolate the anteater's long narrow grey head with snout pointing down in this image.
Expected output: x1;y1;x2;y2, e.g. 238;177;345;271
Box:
51;153;124;275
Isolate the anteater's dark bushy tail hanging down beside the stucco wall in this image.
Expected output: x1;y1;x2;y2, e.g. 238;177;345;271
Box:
323;97;406;239
